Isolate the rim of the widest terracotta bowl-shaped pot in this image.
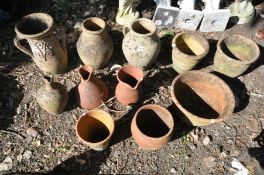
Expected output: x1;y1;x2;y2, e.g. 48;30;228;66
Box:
171;70;235;126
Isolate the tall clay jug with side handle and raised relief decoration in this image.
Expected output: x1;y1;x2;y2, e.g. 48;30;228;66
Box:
14;13;68;74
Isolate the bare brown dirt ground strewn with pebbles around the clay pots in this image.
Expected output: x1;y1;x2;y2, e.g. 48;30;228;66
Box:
0;0;264;175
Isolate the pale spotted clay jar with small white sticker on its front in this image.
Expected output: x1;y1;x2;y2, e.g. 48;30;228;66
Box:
122;18;160;68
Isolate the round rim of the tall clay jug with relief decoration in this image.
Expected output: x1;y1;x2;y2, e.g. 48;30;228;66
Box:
15;13;54;39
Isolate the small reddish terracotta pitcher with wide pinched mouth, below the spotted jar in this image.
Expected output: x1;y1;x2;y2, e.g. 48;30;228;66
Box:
115;65;144;105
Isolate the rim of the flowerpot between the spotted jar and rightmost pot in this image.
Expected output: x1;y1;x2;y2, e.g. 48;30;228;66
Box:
171;32;210;60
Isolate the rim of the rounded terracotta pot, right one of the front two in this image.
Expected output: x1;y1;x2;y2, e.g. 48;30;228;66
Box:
131;104;174;141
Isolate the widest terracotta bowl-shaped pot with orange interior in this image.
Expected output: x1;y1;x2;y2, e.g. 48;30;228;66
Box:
171;71;235;126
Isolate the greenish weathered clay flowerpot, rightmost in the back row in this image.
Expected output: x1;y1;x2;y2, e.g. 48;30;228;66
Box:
214;35;260;77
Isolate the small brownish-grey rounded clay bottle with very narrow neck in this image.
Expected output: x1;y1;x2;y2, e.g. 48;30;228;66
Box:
37;76;68;115
